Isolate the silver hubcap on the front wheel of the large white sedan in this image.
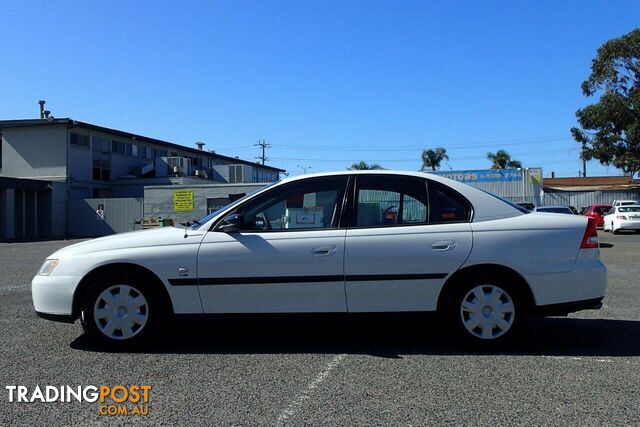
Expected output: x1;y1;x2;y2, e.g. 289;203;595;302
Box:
93;285;149;340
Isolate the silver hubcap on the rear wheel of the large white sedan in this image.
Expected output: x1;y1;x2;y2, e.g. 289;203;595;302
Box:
460;285;515;340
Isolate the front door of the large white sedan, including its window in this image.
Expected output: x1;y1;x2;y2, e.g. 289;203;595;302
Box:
198;176;348;313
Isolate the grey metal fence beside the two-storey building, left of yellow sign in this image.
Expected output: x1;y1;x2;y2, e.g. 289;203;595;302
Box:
67;198;143;237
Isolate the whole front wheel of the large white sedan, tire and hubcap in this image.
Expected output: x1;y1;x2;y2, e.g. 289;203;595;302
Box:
81;278;161;347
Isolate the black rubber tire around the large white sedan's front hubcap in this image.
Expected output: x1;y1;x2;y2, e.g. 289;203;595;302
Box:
80;274;166;349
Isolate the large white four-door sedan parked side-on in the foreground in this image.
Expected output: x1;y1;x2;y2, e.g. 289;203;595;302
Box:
32;171;607;345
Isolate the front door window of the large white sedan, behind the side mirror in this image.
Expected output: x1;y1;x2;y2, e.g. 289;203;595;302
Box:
236;176;347;231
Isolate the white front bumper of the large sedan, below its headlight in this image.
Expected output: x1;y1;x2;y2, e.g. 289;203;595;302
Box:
31;276;80;317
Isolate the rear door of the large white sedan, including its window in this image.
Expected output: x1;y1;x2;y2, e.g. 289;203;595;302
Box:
345;174;472;312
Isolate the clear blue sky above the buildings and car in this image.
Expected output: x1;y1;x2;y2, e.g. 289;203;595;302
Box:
0;0;640;176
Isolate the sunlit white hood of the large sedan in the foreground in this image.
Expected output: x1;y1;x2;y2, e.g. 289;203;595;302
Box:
48;227;204;259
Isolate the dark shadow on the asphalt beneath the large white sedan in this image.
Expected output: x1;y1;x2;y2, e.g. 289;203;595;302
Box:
71;314;640;358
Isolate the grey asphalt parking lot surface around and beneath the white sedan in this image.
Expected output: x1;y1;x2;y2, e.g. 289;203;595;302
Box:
0;236;640;425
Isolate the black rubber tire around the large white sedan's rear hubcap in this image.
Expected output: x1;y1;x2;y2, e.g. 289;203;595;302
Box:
446;275;528;349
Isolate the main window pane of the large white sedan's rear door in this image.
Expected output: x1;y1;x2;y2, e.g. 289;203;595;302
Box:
355;175;429;227
